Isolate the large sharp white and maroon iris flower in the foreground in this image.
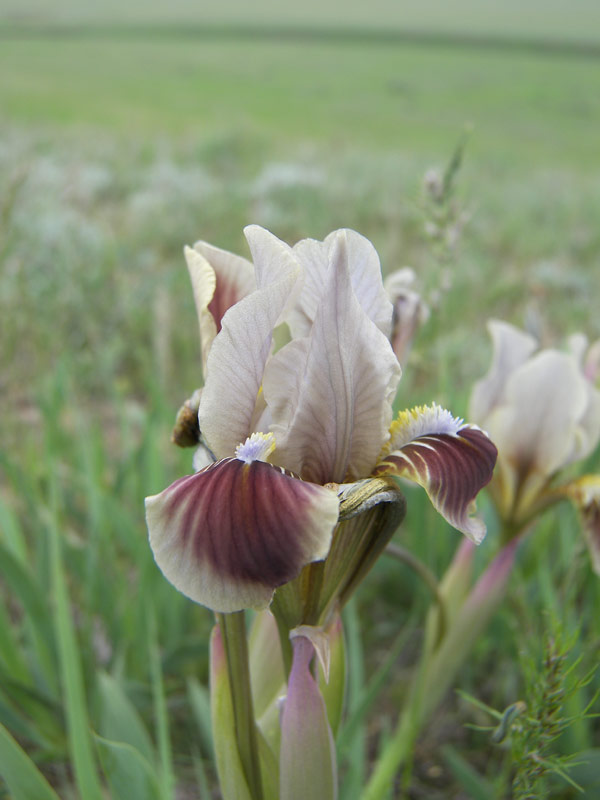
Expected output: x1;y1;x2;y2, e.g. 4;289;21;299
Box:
146;225;496;612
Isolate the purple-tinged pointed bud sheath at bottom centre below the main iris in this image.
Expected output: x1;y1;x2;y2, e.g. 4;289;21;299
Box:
279;636;337;800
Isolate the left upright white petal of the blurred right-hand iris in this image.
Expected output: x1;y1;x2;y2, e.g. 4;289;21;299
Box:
469;319;537;427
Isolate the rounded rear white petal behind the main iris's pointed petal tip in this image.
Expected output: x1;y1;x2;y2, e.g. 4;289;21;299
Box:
289;228;393;338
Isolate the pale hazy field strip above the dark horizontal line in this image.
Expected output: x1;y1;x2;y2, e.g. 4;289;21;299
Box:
0;0;600;42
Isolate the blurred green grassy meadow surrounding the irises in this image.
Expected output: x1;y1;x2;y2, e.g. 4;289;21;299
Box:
0;9;600;800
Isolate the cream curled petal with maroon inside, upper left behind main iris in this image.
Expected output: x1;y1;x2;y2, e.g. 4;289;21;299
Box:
184;242;256;369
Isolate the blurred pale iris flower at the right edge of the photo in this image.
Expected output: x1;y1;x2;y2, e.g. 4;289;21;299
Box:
469;320;600;574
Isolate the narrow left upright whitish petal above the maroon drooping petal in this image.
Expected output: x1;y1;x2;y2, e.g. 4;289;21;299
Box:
198;253;300;458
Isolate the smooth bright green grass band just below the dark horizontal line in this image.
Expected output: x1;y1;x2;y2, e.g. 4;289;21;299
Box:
0;33;600;170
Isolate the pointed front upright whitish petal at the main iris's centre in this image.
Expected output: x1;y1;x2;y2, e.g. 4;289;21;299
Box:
264;228;401;483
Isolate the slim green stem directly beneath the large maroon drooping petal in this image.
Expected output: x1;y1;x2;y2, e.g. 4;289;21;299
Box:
217;611;263;800
